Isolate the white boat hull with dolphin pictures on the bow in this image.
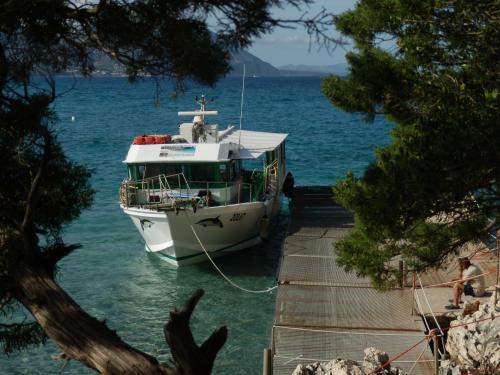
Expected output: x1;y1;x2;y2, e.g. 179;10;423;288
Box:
122;201;271;266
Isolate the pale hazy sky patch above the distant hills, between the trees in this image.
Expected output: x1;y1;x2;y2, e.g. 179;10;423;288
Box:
249;0;356;67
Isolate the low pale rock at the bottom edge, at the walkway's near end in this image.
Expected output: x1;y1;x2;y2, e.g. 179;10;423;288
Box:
292;348;405;375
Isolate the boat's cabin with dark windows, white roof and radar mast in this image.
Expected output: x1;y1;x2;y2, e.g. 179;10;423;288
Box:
119;98;287;209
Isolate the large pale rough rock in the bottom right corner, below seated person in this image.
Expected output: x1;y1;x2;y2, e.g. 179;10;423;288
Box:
441;303;500;375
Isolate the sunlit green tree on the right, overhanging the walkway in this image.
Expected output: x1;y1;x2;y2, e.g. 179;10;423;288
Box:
323;0;500;287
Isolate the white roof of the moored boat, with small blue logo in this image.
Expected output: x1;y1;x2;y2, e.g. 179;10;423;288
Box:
123;128;288;163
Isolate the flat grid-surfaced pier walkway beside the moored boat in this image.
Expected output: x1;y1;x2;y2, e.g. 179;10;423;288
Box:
272;187;433;375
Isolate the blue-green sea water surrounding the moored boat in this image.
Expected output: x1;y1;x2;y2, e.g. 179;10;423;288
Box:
0;77;390;375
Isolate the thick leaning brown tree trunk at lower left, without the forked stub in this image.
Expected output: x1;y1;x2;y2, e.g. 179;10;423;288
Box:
16;267;172;375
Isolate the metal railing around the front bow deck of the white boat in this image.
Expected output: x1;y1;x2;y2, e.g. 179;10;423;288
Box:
120;173;201;210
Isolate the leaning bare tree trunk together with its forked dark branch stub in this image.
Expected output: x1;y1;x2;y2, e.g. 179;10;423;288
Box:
15;267;227;375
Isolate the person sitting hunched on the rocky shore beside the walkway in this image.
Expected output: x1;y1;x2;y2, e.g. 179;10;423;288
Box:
445;257;485;310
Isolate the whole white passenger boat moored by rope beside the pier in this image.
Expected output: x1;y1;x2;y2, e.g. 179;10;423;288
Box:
119;96;287;266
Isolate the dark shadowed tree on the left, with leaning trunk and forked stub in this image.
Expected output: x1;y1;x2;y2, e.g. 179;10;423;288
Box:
0;0;336;375
